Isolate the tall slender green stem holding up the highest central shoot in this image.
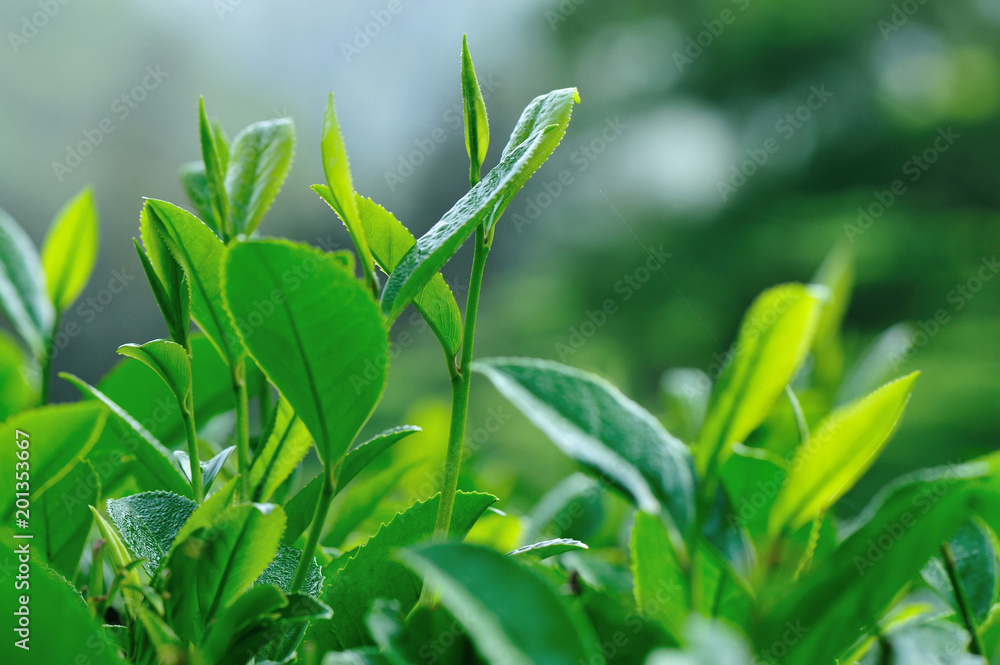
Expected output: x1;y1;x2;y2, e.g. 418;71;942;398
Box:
434;226;490;540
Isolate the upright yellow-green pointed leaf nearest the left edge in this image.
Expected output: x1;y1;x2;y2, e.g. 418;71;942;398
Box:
42;188;100;312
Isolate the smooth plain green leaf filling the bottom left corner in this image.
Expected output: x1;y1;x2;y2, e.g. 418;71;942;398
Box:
0;535;121;665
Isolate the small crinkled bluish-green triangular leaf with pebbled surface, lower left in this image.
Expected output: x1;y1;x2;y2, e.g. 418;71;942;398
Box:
107;492;198;575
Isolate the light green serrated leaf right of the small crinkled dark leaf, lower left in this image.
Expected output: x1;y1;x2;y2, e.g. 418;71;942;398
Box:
166;504;285;634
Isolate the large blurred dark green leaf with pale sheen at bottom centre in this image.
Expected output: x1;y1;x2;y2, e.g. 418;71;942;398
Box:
399;544;600;665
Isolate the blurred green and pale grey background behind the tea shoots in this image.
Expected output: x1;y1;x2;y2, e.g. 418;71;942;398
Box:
0;0;1000;511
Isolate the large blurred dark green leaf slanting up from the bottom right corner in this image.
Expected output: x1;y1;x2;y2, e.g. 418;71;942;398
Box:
755;463;990;665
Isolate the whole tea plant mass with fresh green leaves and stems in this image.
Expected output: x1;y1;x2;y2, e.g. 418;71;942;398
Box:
0;35;1000;665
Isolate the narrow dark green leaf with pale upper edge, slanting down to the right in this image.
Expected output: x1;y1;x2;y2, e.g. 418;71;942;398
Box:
59;370;191;496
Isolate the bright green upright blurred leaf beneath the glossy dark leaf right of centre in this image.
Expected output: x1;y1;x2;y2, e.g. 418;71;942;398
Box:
632;512;691;641
